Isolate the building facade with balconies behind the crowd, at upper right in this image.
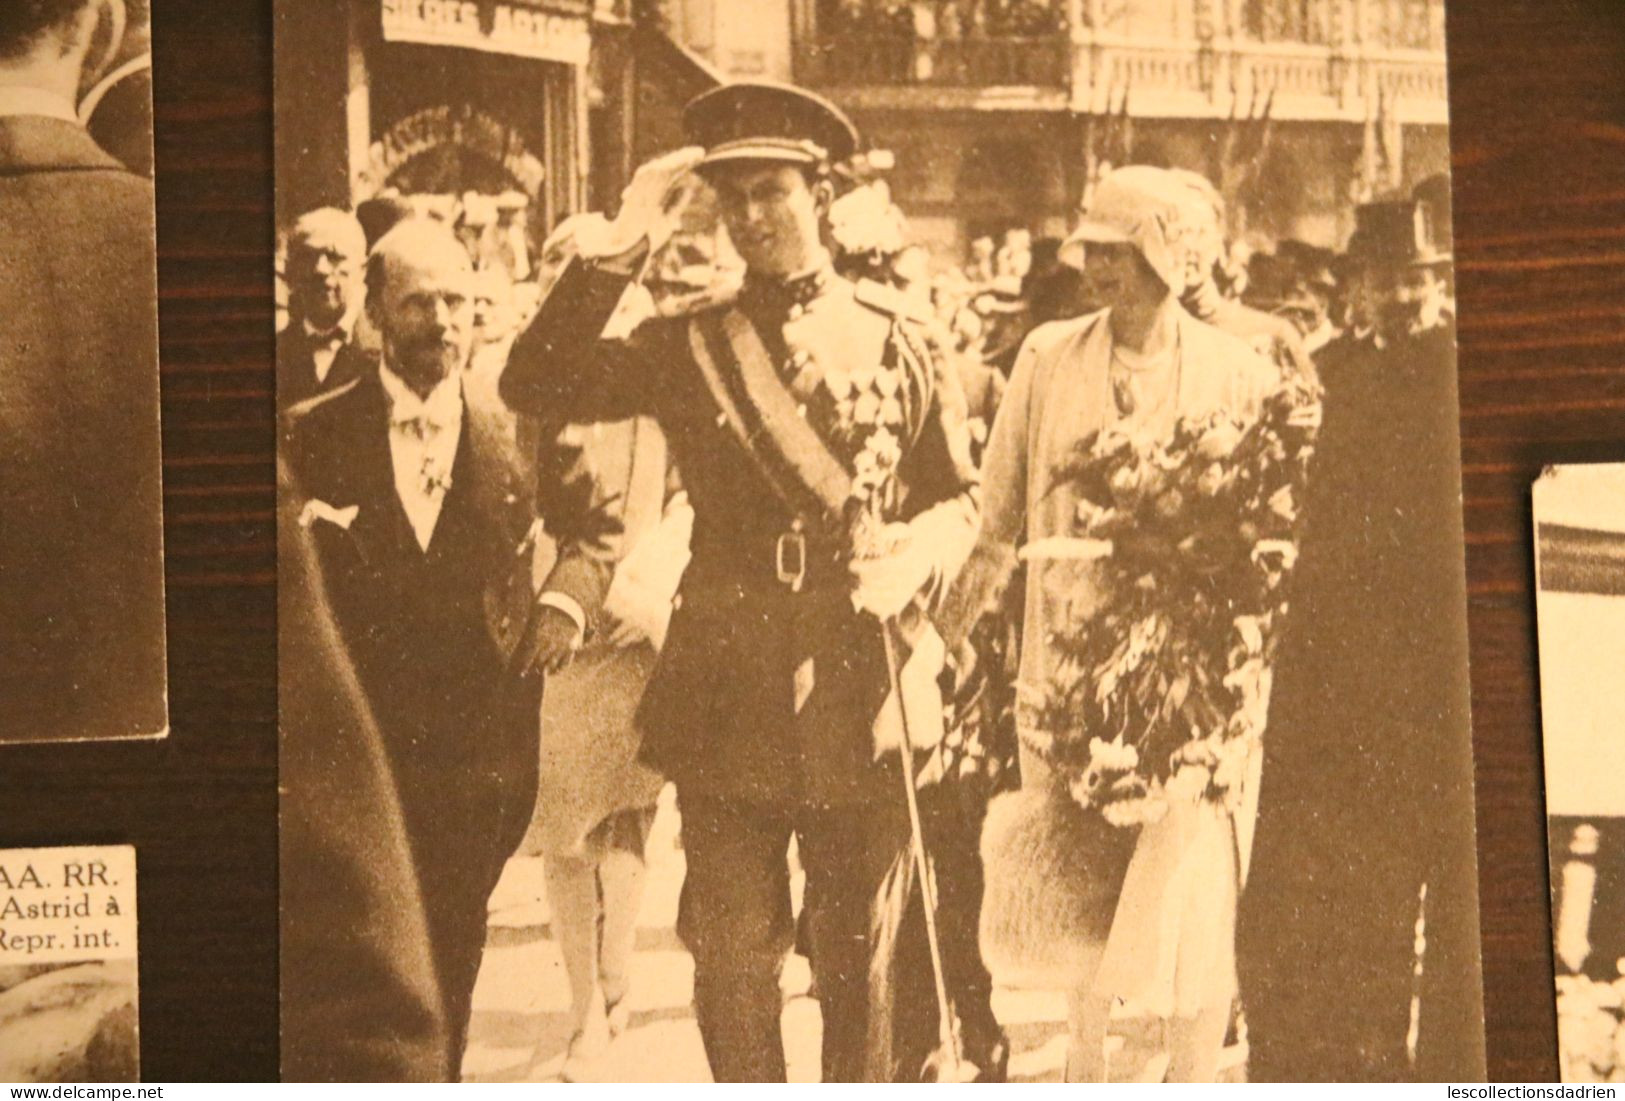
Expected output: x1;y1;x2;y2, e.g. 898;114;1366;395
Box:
663;0;1450;258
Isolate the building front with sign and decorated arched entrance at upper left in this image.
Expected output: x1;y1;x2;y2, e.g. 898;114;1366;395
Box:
276;0;631;245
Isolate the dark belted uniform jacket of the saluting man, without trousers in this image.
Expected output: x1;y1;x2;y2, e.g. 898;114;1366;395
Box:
501;261;978;805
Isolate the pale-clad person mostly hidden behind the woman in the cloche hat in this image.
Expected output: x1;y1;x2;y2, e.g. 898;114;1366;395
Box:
1170;169;1315;380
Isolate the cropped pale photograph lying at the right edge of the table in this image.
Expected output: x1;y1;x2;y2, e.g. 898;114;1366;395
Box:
1534;464;1625;1083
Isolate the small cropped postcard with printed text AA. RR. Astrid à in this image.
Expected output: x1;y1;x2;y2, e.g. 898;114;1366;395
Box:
0;846;140;1083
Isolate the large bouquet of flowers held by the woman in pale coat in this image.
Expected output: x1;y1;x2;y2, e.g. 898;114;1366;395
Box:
1022;382;1320;827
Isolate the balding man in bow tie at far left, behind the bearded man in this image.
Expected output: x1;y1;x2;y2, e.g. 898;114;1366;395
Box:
276;206;367;409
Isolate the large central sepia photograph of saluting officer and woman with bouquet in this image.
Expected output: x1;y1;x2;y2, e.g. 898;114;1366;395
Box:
275;0;1485;1082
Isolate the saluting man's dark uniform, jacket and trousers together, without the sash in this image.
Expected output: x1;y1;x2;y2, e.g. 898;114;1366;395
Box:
502;254;977;1082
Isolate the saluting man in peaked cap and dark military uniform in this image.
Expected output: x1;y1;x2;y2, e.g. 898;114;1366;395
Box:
502;84;977;1082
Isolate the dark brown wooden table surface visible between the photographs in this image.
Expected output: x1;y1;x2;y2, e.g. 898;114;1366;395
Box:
0;0;1625;1082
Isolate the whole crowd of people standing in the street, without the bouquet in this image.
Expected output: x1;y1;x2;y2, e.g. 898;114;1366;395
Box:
278;79;1482;1080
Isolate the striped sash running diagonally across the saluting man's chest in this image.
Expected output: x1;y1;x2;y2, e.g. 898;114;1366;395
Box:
689;309;852;533
